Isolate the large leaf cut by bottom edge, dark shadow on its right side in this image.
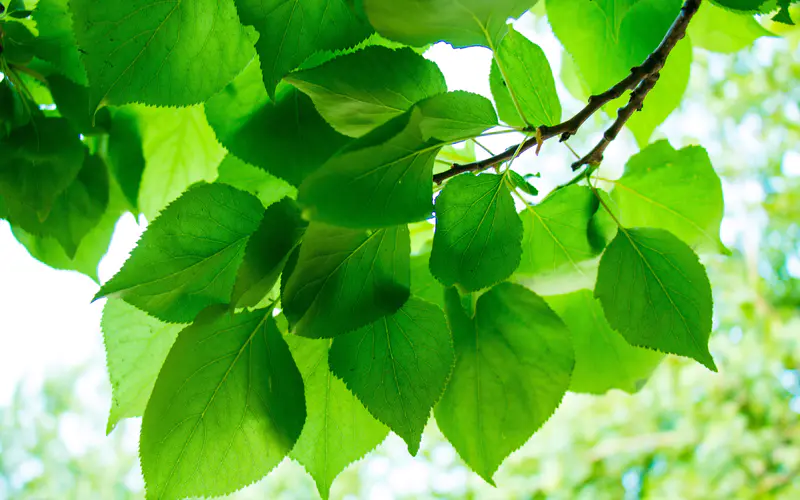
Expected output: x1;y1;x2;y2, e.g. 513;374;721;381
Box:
139;309;306;500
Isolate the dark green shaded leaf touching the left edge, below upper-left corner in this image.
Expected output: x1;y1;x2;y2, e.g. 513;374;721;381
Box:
0;118;85;220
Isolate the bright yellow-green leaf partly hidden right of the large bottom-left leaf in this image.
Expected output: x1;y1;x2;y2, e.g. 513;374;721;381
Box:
286;335;389;500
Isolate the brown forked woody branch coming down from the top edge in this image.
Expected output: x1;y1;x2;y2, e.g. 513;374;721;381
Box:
433;0;702;184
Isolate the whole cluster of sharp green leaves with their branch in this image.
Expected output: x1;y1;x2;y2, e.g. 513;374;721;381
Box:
0;0;793;499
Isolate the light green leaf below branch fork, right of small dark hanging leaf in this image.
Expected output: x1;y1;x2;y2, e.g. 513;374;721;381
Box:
517;186;599;275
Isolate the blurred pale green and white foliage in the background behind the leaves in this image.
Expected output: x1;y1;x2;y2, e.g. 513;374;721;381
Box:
0;8;800;500
